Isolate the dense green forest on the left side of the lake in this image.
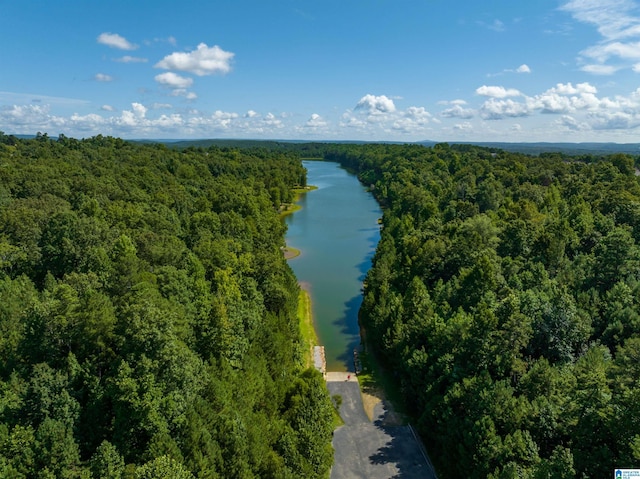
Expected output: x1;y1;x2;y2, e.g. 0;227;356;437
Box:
0;133;333;479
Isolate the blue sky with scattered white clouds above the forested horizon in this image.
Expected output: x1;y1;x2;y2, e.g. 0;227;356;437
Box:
0;0;640;143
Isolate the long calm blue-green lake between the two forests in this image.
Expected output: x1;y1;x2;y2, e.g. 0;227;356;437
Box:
285;161;382;371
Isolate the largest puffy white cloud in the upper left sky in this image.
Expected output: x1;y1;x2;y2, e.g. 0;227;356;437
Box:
155;43;235;76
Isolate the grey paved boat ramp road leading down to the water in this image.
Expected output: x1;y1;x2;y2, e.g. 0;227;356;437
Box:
327;373;436;479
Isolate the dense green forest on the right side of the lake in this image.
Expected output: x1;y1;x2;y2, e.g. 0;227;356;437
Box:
325;144;640;479
